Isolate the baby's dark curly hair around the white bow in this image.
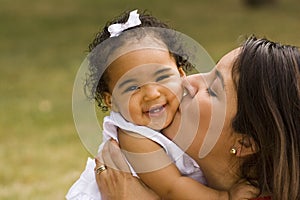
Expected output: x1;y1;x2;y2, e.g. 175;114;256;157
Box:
84;11;193;111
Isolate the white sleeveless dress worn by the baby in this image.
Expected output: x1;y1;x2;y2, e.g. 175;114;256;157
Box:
66;112;206;200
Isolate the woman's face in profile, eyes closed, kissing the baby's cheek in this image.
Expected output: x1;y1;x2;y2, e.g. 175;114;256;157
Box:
164;49;239;161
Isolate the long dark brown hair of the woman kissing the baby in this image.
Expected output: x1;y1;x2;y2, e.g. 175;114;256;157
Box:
232;36;300;200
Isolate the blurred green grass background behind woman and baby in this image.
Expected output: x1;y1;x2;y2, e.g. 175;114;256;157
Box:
0;0;300;200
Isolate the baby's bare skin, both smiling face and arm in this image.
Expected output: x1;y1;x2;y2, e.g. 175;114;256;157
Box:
105;49;228;199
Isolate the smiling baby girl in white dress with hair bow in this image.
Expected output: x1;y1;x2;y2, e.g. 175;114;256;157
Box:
66;11;255;199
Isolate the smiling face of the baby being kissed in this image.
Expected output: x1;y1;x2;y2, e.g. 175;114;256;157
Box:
104;49;184;130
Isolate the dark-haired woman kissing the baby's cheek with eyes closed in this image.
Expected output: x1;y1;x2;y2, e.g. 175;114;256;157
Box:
96;37;300;200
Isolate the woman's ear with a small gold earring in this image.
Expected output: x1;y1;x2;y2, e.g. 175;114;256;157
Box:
235;134;258;157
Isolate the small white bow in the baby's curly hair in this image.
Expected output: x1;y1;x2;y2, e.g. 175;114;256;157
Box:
108;10;142;37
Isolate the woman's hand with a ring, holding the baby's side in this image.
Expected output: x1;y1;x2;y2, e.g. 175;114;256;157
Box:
95;140;160;200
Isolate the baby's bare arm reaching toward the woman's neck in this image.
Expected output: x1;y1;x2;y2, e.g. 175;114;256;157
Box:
118;130;229;200
